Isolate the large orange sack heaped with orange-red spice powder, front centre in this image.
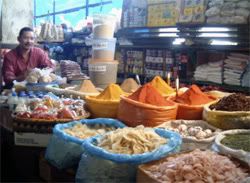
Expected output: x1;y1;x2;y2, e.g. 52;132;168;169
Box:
118;84;177;127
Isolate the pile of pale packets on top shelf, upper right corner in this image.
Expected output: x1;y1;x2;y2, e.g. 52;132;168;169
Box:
205;0;250;24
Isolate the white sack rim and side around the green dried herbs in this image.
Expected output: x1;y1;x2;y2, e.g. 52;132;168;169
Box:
215;129;250;166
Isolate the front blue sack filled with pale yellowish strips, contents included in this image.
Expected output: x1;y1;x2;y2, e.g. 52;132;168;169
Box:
76;126;181;183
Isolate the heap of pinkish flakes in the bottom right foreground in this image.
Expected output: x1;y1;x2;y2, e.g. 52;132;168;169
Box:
143;150;248;183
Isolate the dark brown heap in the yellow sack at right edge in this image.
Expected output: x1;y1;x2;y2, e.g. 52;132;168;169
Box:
210;94;250;111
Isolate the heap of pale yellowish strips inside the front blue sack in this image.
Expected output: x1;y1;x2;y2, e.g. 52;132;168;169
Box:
98;126;168;154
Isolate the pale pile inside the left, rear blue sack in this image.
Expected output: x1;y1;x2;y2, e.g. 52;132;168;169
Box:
64;123;116;139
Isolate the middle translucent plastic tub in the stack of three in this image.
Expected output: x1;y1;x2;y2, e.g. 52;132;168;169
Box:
92;38;116;60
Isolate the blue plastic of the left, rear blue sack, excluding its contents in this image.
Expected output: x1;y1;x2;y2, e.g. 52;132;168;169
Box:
45;118;125;169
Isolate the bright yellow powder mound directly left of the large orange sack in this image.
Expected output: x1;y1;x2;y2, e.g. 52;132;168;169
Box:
95;84;124;100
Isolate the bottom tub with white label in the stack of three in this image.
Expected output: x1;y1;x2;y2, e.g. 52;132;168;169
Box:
88;60;118;89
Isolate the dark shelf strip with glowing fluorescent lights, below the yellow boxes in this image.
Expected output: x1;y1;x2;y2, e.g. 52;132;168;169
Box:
116;24;250;51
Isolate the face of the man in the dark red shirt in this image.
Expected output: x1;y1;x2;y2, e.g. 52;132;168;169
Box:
18;31;35;50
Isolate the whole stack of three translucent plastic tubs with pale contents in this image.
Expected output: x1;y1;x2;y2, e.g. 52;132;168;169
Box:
88;15;118;88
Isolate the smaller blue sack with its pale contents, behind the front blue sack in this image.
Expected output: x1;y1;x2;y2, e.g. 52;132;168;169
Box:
45;118;125;169
